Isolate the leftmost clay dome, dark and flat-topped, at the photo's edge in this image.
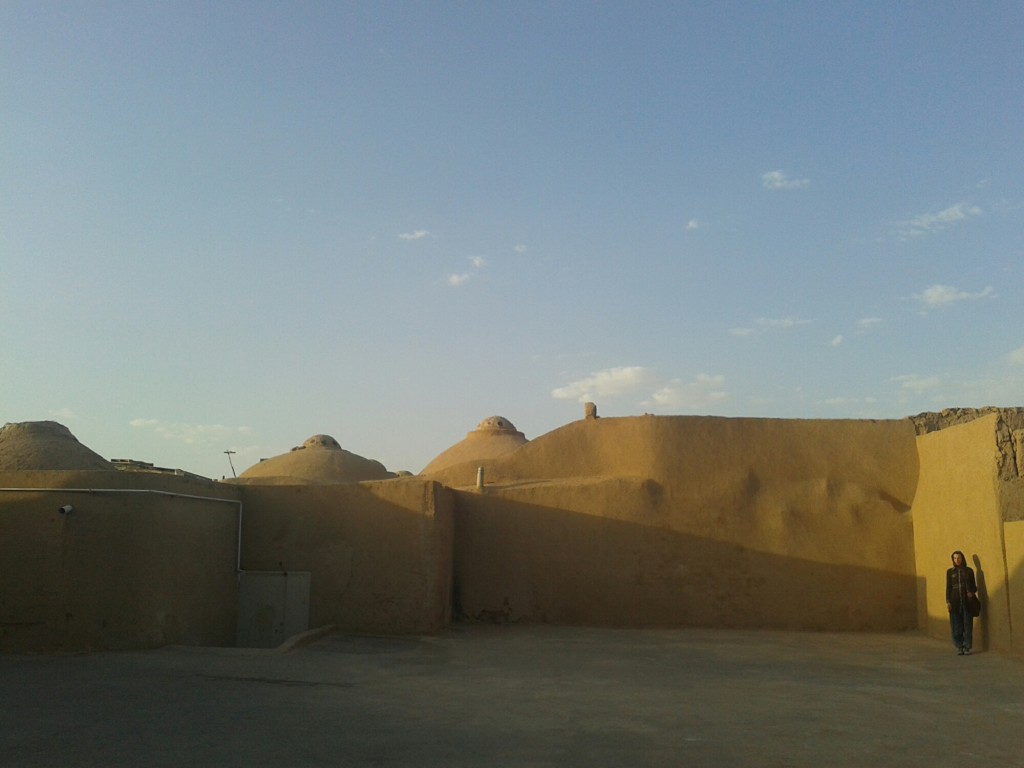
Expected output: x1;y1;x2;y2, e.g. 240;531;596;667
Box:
0;421;114;471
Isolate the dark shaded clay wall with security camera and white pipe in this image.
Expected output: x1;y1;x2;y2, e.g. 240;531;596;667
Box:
0;471;238;651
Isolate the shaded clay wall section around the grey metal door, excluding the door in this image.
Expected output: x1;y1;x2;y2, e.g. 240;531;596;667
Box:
240;477;453;634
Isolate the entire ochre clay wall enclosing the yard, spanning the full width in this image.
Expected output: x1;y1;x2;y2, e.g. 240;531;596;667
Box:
0;414;1024;655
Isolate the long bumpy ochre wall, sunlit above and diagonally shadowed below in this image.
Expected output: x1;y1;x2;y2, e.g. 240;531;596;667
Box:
448;417;918;631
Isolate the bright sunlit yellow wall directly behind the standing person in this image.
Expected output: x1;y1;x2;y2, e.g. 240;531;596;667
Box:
913;416;1011;651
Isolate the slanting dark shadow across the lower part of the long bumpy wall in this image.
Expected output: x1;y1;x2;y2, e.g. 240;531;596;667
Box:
454;493;918;632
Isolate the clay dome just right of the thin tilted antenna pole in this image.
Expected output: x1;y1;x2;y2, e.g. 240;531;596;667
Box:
238;434;394;484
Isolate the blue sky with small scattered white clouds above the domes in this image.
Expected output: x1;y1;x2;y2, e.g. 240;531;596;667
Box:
0;0;1024;478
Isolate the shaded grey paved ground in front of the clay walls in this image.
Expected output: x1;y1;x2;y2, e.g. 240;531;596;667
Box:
0;627;1024;768
